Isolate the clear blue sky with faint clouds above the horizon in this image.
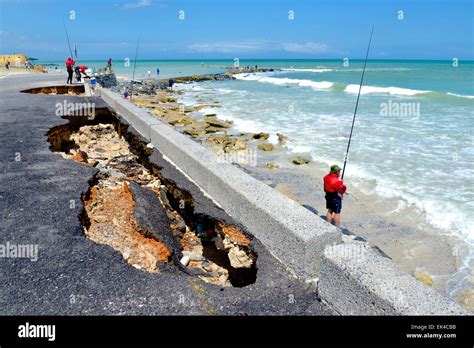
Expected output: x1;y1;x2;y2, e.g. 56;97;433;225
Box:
0;0;474;60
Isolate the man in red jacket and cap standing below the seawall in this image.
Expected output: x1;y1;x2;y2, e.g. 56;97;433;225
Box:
324;164;346;227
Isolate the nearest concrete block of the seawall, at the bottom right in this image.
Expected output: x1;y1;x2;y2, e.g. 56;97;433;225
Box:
318;243;467;315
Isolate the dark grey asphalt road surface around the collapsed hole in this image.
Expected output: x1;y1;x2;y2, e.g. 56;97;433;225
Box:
0;75;332;315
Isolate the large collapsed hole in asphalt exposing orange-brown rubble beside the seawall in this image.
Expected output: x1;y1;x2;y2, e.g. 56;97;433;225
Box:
48;113;257;287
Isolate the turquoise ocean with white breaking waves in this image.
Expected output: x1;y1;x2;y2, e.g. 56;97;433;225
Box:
41;59;474;293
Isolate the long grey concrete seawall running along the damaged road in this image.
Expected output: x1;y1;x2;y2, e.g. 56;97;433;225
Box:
100;89;467;315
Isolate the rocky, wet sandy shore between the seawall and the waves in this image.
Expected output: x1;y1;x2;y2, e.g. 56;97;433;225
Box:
113;69;474;311
